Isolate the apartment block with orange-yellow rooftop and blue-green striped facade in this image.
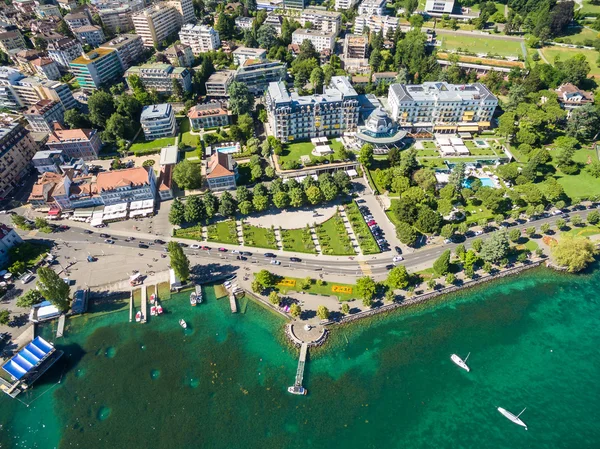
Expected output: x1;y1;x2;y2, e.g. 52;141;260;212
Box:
69;48;123;89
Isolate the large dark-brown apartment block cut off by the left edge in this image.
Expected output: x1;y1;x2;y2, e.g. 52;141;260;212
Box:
0;123;38;198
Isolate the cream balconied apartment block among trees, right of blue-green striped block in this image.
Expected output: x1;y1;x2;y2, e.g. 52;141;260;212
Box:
125;63;192;95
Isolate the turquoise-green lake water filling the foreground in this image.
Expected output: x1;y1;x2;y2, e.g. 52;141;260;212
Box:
0;269;600;449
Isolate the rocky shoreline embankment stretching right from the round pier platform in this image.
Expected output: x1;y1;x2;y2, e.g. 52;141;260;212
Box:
327;260;543;326
